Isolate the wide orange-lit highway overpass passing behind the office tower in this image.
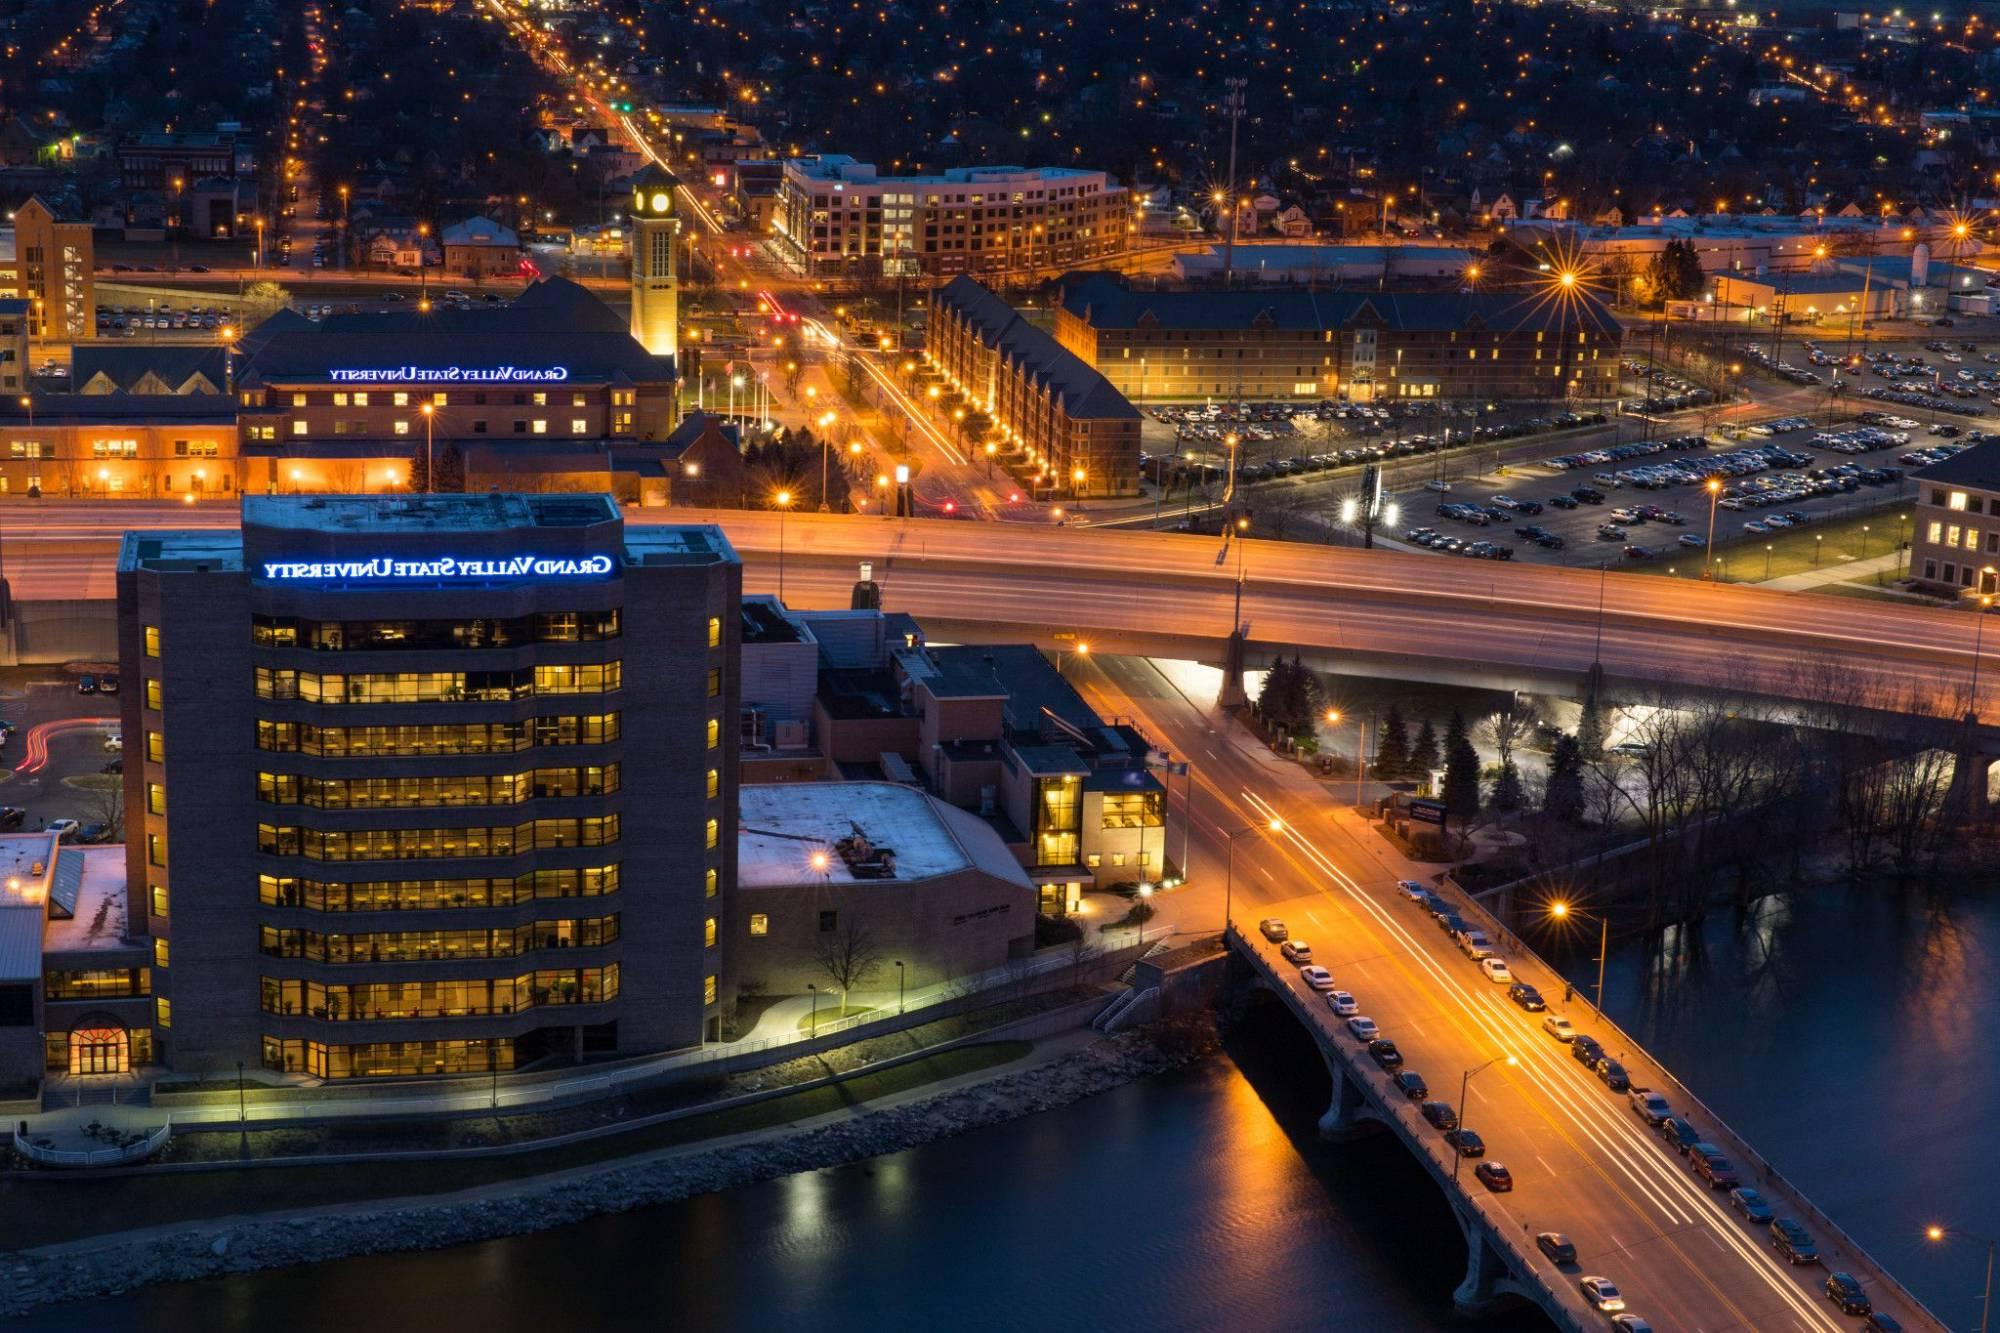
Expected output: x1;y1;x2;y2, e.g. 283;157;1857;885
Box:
0;502;1976;705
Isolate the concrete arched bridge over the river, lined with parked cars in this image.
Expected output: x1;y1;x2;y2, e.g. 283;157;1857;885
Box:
1222;904;1944;1333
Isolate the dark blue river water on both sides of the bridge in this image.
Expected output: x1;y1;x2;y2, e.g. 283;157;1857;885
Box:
22;876;2000;1333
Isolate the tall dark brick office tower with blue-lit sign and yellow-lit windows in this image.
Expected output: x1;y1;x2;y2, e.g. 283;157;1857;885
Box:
118;494;742;1079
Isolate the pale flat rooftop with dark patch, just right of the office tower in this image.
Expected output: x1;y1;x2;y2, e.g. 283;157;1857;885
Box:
736;783;974;889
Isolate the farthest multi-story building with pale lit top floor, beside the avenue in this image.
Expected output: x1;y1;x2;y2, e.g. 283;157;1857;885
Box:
772;154;1132;278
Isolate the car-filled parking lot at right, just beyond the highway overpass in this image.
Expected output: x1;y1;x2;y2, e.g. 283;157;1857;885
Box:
1396;410;1936;564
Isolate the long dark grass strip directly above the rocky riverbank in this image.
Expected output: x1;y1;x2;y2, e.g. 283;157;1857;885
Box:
0;1041;1032;1249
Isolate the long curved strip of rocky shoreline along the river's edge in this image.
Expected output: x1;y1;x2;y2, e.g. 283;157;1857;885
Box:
0;1015;1216;1317
